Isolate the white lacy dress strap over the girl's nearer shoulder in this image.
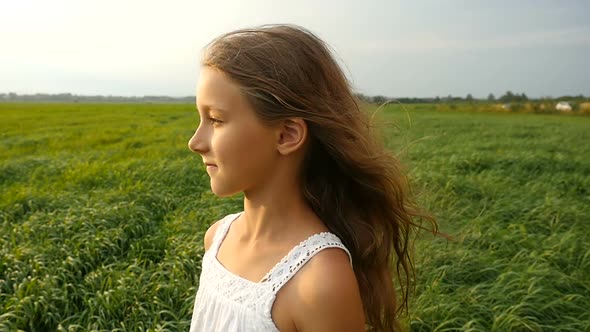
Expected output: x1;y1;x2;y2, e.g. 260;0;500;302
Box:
261;232;352;294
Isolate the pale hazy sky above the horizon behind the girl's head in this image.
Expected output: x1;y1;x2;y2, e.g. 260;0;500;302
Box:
0;0;590;98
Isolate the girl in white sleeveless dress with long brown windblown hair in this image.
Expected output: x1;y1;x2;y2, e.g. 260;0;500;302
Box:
188;25;437;332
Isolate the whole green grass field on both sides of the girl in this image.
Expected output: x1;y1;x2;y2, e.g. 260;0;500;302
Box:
0;104;590;331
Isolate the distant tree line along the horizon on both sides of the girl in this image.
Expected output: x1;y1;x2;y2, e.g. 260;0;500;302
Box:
0;91;590;104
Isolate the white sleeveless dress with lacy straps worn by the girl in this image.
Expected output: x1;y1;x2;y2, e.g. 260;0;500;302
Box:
190;212;352;332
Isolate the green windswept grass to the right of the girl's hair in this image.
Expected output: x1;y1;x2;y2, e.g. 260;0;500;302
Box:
381;106;590;331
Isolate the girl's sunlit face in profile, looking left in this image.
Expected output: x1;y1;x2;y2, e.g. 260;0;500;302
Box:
188;67;279;196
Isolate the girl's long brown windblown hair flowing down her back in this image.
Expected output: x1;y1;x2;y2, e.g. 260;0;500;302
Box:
201;24;438;331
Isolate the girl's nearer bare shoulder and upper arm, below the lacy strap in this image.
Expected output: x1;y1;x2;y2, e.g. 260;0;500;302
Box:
292;248;365;332
